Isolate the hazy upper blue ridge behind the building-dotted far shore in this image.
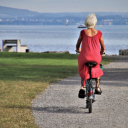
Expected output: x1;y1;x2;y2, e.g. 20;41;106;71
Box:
0;6;128;18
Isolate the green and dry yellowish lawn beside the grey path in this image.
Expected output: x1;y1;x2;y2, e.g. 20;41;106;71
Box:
0;52;111;128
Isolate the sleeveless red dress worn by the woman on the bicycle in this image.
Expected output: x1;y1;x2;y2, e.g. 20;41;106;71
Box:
78;30;103;81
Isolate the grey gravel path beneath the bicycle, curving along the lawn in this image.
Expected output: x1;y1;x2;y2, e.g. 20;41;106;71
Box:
32;57;128;128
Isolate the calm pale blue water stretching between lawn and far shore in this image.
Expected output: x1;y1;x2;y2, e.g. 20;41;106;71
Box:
0;25;128;55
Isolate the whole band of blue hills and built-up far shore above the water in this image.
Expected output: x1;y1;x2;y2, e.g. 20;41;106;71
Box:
0;6;128;25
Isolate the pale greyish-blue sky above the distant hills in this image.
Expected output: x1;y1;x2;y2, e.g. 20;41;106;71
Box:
0;0;128;13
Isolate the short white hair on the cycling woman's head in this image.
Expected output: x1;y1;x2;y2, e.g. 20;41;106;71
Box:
85;13;97;28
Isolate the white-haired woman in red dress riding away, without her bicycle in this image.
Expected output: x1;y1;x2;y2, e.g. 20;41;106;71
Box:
76;13;105;94
